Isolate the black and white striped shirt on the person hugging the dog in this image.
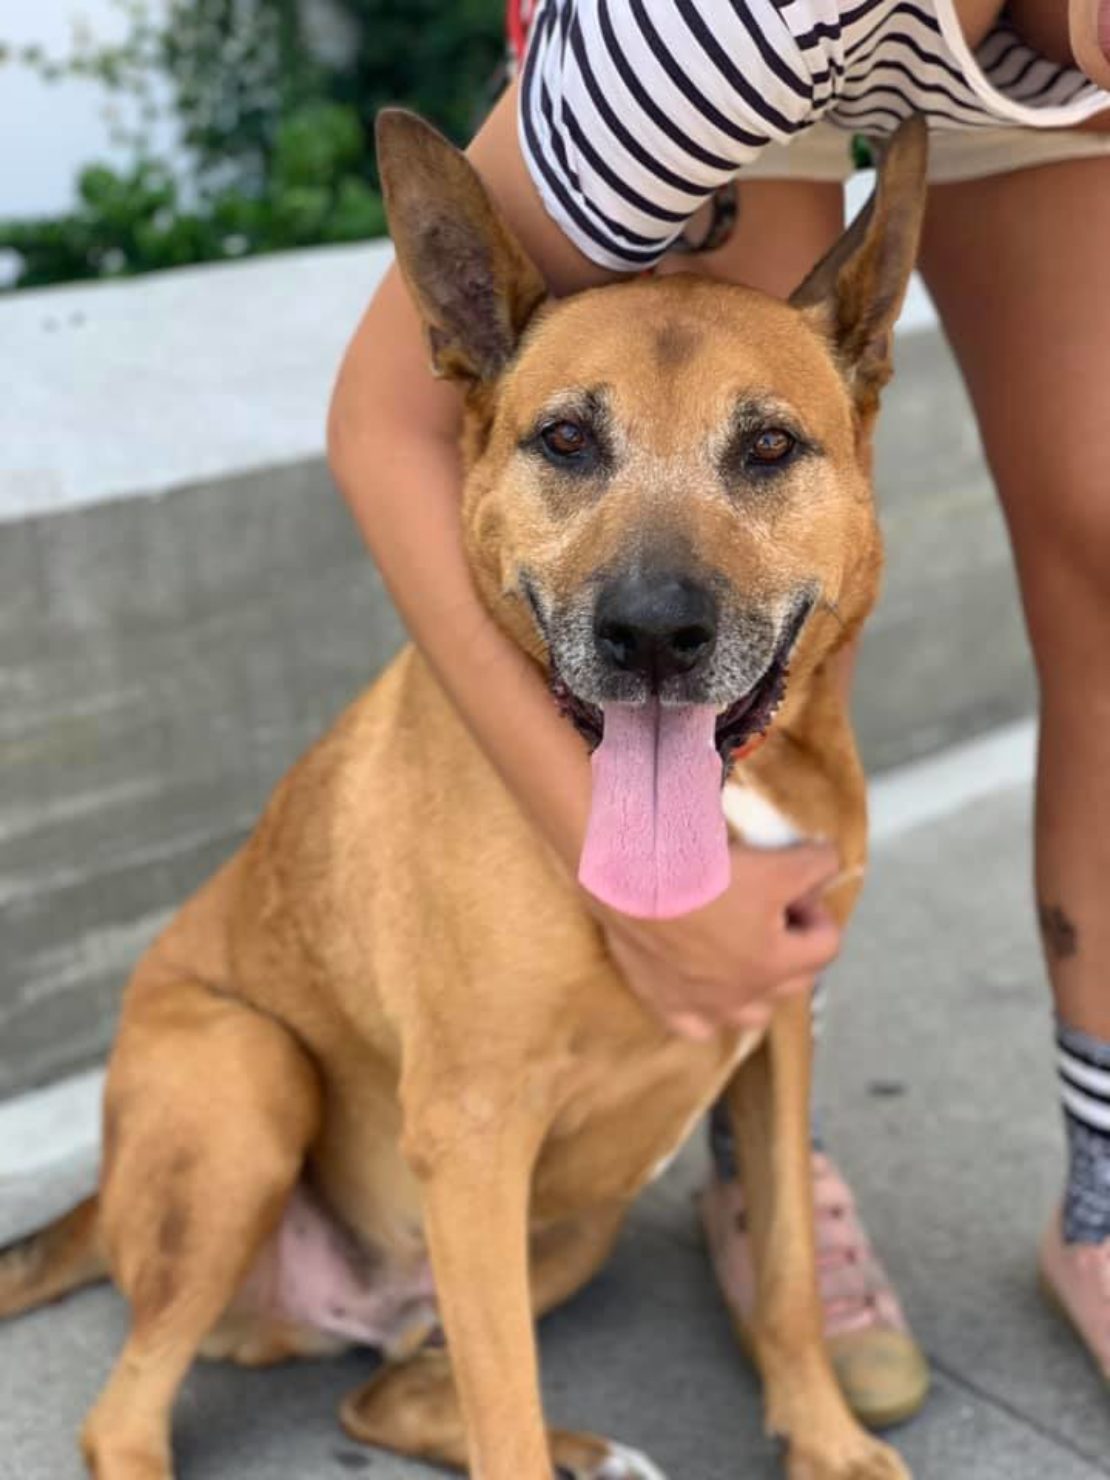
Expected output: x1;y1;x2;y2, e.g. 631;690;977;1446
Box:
519;0;1110;269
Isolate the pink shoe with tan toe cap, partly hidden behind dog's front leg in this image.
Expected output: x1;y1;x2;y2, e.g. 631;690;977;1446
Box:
702;1151;929;1428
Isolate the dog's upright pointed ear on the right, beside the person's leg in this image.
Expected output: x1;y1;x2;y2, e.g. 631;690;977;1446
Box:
790;115;928;414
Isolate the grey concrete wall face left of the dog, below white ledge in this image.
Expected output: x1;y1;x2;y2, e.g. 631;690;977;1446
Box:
0;462;401;1095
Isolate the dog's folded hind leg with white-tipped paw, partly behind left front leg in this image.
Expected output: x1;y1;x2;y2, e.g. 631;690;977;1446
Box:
342;1208;663;1480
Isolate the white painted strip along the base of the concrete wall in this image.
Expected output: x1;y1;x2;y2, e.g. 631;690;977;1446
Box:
0;721;1036;1184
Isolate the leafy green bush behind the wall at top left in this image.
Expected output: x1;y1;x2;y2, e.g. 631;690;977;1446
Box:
0;0;503;287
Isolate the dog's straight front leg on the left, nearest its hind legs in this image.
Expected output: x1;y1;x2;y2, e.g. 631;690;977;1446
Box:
406;1085;552;1480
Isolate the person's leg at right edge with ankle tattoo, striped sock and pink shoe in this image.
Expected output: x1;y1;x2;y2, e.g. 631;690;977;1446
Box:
924;150;1110;1373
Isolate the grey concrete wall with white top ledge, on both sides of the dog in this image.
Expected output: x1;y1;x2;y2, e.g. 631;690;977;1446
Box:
0;247;1033;1095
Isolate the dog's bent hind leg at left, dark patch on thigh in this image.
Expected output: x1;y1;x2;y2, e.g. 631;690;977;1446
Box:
83;968;320;1480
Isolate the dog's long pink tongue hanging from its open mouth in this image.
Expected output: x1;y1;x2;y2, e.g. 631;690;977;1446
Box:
579;699;728;919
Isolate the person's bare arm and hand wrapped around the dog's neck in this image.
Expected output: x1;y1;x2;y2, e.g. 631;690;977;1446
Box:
329;89;838;1032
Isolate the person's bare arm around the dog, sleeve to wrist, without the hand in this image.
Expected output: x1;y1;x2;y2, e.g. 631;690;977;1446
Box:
329;86;607;867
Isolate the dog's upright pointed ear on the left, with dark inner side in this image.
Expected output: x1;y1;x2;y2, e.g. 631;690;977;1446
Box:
377;108;546;380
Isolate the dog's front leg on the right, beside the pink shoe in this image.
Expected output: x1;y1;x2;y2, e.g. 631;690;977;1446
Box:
725;996;909;1480
